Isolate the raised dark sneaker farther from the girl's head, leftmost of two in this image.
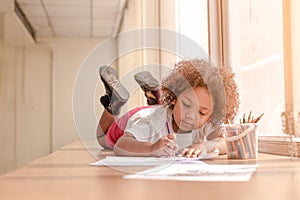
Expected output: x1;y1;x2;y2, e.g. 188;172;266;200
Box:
99;66;130;115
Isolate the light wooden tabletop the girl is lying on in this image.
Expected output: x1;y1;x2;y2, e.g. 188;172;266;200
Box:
0;142;300;200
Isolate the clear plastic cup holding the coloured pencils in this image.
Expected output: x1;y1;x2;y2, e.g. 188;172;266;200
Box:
222;123;258;159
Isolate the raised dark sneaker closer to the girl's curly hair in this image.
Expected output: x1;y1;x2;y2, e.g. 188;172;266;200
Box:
134;71;160;105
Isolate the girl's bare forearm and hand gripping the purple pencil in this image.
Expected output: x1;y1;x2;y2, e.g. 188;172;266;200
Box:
114;133;177;156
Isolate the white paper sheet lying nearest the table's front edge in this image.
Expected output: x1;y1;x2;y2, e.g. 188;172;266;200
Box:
124;163;257;182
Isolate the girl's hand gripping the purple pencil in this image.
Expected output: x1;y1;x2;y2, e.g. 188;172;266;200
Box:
151;134;178;157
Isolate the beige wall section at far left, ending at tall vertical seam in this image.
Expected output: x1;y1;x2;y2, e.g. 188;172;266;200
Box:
0;12;52;173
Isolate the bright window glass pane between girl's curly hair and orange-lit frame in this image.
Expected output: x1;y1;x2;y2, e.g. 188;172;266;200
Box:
227;0;285;135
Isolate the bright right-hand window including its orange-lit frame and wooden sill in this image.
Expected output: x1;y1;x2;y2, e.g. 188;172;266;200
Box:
222;0;300;157
